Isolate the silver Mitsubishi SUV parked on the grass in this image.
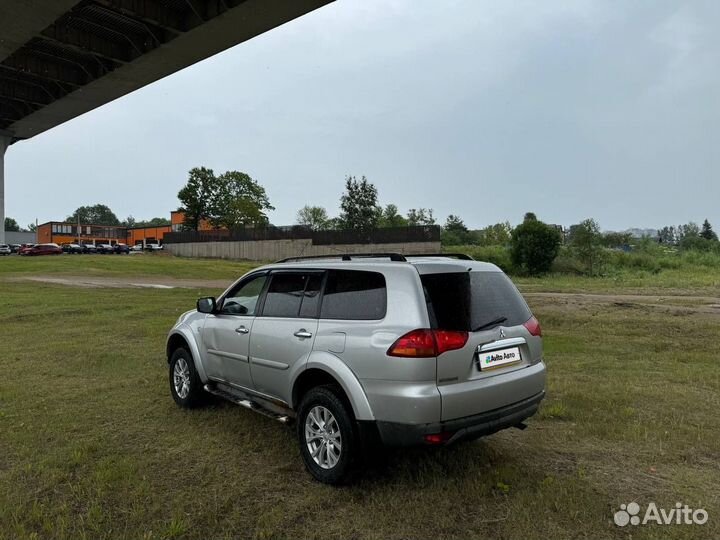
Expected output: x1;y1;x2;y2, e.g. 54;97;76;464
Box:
167;254;545;484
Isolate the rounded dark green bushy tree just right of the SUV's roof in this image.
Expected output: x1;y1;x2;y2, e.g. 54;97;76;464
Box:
510;214;561;276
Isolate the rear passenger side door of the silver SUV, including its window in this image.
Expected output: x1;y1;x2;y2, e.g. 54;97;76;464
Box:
250;272;324;403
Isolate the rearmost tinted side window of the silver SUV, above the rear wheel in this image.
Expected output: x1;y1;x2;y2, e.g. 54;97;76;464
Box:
320;270;387;320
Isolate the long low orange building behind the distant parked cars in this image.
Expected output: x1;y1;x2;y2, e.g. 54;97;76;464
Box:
37;210;212;246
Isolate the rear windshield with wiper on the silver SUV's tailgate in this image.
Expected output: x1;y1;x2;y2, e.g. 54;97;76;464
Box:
420;272;532;331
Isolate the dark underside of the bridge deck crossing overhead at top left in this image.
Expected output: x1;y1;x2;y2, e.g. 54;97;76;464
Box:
0;0;332;141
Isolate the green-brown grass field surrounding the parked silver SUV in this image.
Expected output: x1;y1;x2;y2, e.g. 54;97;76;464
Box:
0;255;720;539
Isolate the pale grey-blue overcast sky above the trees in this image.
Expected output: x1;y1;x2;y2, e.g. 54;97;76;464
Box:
5;0;720;230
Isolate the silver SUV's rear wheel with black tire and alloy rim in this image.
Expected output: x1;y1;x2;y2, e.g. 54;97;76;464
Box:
297;386;358;485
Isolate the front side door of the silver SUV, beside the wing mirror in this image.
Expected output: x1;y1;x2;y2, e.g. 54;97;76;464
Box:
203;275;267;388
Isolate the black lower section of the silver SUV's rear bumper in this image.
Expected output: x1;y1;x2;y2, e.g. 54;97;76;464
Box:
376;390;545;446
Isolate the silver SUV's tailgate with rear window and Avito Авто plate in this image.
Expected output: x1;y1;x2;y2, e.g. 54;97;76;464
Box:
420;271;542;419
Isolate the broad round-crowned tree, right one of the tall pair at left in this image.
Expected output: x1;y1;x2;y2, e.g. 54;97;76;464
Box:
210;171;275;229
